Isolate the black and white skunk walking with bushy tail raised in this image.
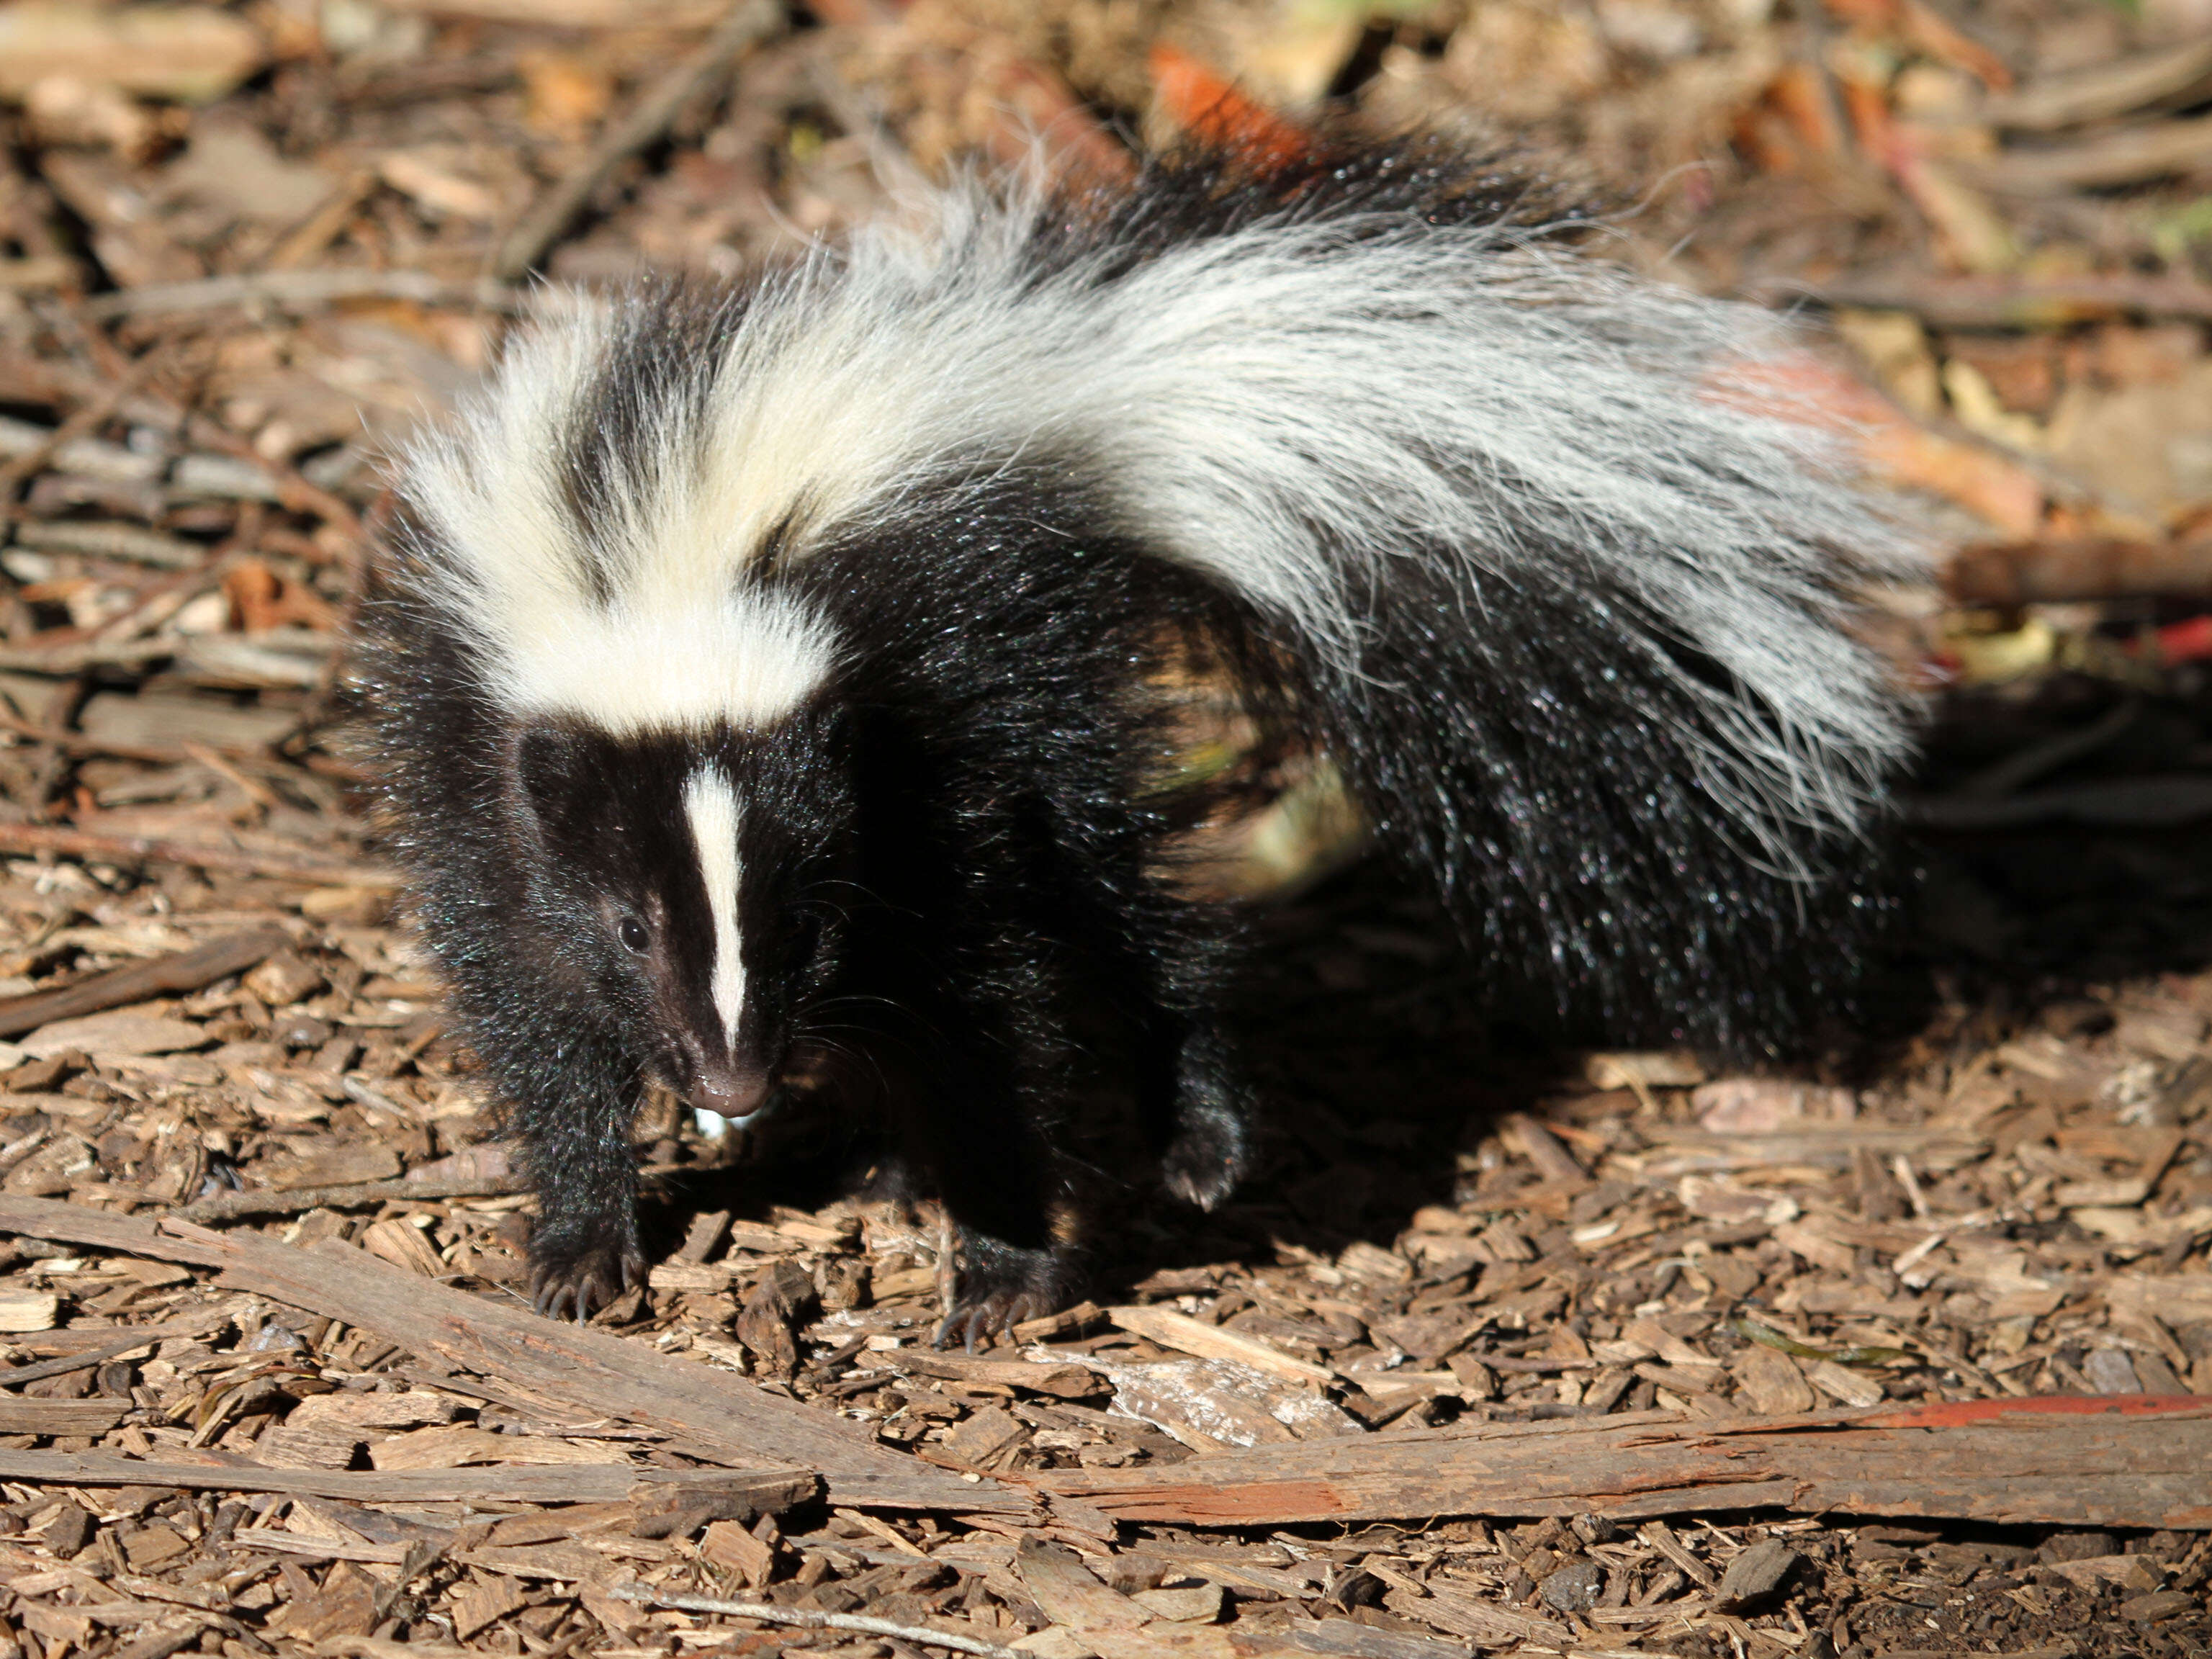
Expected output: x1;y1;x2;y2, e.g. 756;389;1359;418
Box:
365;144;1913;1341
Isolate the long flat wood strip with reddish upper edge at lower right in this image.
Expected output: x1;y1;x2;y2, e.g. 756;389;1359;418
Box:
1031;1395;2212;1531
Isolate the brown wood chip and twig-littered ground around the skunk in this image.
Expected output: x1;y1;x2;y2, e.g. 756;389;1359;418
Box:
0;0;2212;1659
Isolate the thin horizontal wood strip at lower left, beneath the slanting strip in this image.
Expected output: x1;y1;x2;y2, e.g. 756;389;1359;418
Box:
0;1449;821;1513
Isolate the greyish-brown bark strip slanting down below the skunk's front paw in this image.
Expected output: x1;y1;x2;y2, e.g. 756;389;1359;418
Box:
0;1197;1033;1517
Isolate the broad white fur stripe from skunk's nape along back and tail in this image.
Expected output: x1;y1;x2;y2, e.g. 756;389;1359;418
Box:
409;174;1927;860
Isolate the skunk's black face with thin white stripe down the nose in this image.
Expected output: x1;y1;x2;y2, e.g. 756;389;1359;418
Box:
511;706;854;1122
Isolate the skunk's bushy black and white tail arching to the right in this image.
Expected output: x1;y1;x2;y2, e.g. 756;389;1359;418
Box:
1004;150;1923;1048
